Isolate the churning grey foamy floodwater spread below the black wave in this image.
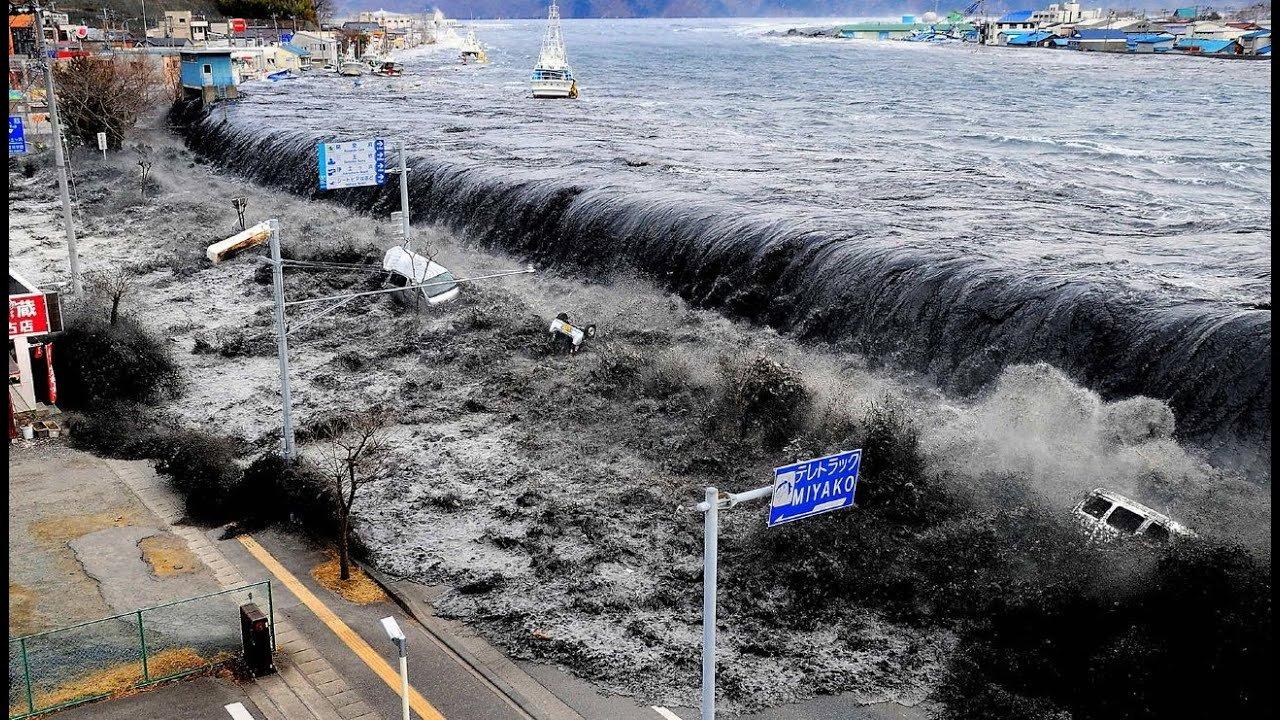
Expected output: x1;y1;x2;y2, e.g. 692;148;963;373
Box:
9;132;1270;710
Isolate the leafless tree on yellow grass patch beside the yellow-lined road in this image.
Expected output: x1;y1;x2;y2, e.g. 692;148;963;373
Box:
317;407;390;580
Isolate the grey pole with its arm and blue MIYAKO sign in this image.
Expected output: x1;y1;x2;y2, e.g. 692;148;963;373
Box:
696;450;863;720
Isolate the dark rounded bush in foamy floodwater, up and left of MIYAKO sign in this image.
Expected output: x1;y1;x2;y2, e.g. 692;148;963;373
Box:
721;355;810;450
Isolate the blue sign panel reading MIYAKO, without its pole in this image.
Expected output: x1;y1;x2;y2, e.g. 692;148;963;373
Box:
769;450;863;528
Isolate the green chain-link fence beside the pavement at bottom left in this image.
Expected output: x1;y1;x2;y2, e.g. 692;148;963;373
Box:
9;580;275;720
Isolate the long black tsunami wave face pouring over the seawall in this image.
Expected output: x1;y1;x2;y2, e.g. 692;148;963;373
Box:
172;105;1271;482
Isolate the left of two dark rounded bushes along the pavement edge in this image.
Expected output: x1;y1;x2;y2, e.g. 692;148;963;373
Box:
156;429;242;524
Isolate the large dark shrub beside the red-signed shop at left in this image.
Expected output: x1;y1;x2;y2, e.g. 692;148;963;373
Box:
54;311;179;410
